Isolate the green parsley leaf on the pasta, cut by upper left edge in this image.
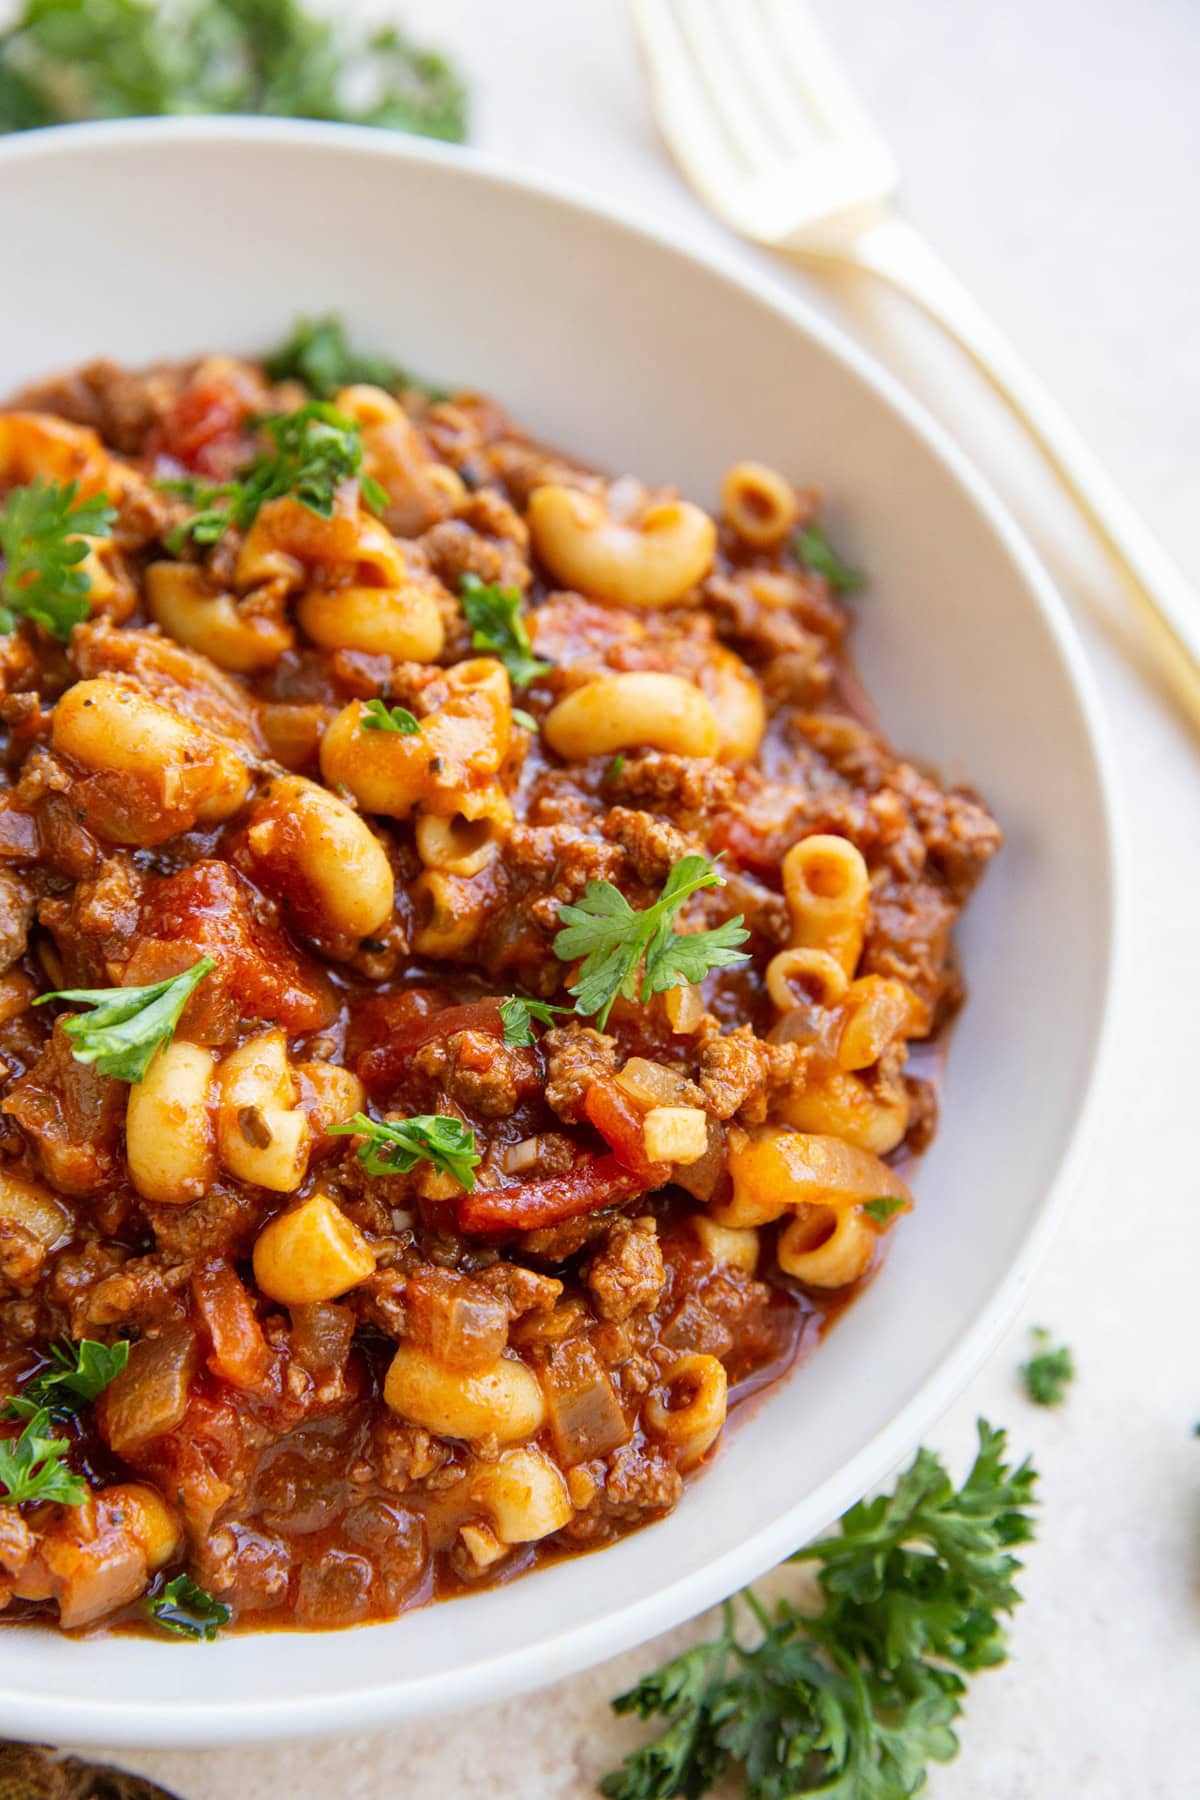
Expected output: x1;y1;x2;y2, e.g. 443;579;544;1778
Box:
0;475;117;641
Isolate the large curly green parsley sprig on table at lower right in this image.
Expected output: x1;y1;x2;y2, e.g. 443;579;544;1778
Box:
599;1420;1036;1800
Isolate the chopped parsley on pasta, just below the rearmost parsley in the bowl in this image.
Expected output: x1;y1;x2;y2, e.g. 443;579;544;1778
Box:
158;400;387;554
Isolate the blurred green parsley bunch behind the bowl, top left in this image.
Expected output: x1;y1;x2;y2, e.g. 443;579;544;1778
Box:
0;0;466;142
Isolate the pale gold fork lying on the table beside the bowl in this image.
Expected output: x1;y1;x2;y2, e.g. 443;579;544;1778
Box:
630;0;1200;725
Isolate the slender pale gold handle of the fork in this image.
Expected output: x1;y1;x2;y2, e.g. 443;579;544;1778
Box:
793;218;1200;727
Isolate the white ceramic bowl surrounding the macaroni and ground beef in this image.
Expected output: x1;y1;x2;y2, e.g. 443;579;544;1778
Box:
0;121;1115;1744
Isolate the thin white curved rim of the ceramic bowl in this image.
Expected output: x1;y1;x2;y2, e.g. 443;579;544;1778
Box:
0;115;1128;1748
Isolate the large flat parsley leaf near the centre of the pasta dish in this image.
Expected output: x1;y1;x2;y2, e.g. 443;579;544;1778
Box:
554;857;750;1030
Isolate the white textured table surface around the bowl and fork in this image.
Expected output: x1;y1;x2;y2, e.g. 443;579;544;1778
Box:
89;0;1200;1800
